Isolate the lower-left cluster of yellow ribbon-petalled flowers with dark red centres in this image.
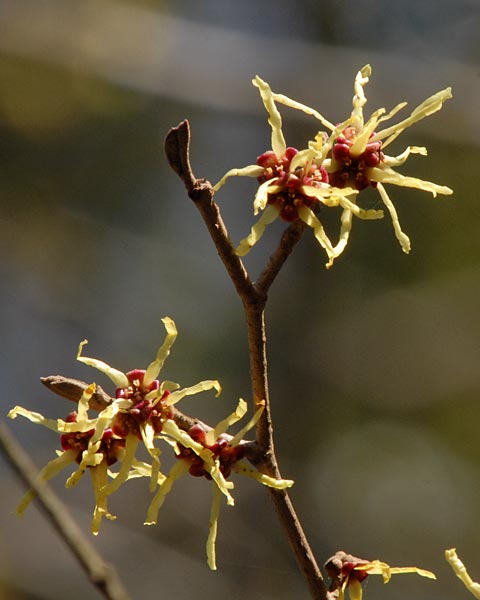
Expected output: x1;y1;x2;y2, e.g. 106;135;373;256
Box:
8;317;293;569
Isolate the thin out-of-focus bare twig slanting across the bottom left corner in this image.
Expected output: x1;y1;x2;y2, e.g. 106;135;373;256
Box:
0;422;129;600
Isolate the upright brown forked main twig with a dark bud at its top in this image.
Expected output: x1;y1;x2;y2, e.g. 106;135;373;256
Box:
165;121;329;600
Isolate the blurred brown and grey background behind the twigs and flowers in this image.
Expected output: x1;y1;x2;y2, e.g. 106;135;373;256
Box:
0;0;480;600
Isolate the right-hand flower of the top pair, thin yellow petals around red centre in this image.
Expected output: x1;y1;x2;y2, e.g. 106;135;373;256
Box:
272;65;453;254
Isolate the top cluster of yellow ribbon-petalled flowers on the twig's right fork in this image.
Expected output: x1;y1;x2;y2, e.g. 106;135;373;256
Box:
214;65;452;267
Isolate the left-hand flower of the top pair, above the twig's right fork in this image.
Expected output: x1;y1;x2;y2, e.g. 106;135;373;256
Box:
214;76;383;267
